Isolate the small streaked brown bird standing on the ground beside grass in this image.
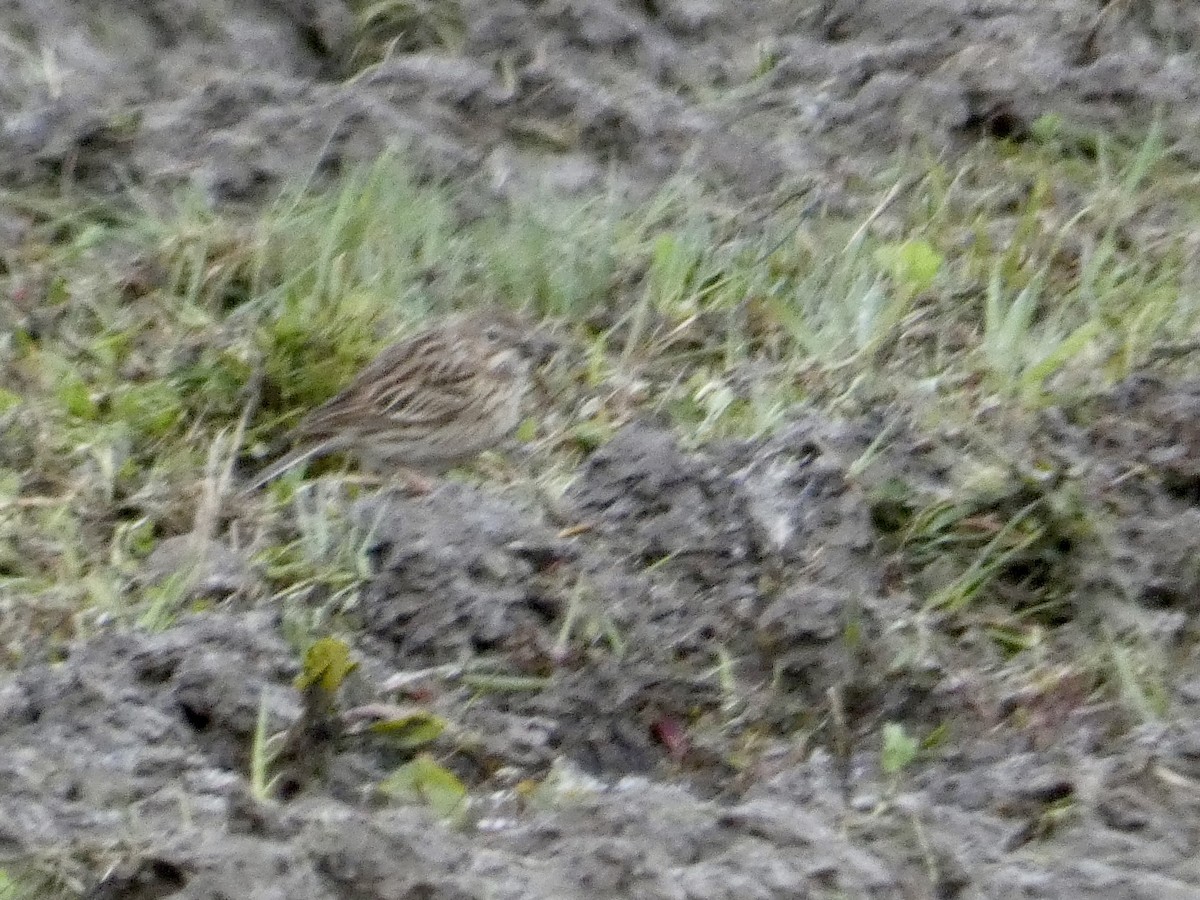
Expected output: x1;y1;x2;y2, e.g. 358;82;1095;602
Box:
245;311;553;491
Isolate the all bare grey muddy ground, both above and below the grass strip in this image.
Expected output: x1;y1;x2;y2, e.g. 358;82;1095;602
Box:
0;0;1200;900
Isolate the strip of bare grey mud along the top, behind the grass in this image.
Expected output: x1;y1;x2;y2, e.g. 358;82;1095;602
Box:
0;0;1200;202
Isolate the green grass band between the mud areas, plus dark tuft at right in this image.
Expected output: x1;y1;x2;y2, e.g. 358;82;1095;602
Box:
0;123;1200;681
